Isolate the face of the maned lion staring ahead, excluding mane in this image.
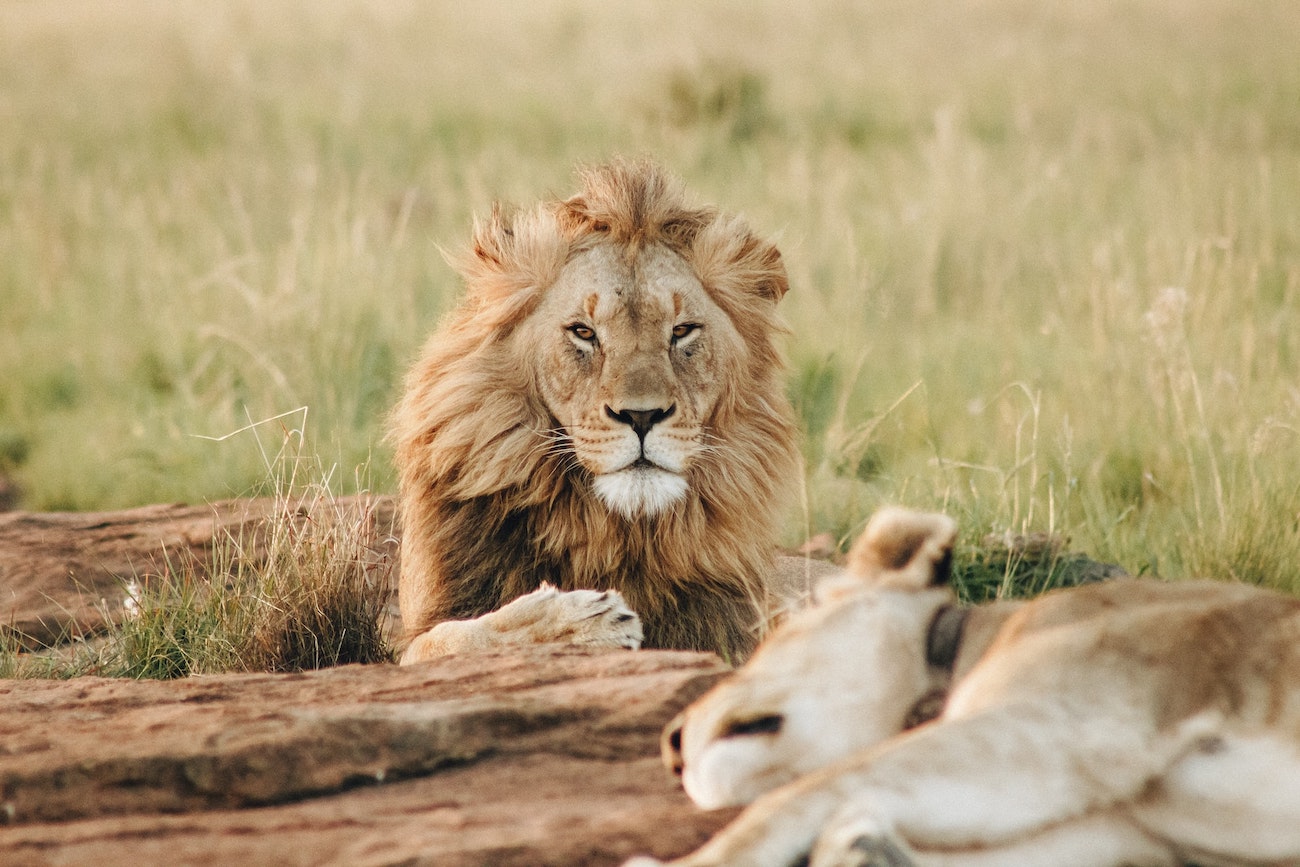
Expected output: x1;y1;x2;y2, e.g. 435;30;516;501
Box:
520;243;744;519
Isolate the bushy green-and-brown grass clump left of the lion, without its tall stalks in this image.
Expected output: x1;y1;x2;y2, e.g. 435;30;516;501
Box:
100;487;393;679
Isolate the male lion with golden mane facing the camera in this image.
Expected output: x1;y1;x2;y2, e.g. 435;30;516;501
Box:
390;161;826;663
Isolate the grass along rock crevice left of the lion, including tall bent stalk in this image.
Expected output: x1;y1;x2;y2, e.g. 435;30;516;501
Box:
0;409;395;680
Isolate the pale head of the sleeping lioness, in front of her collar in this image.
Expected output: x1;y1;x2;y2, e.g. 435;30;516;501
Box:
663;508;956;810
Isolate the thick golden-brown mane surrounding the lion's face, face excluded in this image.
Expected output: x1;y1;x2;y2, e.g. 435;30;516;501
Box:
390;161;798;658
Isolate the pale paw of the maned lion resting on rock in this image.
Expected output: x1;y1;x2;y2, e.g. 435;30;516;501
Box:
489;584;644;650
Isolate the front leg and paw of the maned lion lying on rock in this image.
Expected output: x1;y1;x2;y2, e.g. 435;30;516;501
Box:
400;584;642;666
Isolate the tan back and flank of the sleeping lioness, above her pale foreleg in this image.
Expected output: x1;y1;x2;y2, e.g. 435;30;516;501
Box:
969;578;1300;727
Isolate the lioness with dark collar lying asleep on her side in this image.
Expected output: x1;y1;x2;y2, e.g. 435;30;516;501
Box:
629;510;1300;867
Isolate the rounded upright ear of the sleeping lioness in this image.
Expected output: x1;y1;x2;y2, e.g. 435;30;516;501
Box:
849;507;957;590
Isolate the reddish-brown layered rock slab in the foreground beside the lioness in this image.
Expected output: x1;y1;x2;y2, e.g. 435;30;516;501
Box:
0;647;733;866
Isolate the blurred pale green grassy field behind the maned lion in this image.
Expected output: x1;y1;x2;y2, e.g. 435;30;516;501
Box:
0;0;1300;589
